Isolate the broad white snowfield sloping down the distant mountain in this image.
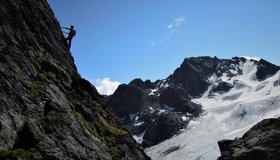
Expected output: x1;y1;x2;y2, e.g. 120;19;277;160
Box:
146;60;280;160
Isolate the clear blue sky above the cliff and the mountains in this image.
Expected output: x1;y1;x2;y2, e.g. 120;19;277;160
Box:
48;0;280;94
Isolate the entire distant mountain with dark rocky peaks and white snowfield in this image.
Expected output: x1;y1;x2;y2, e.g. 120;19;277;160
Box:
108;57;280;160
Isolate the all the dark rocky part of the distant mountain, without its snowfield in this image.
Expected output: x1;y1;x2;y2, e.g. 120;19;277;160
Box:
108;57;280;147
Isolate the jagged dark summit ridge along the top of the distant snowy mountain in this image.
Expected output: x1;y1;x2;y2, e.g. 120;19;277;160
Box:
167;57;280;96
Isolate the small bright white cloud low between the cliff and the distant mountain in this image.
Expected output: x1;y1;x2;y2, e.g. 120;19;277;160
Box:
92;77;121;95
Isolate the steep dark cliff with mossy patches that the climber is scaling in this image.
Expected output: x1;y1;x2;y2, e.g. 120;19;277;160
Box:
0;0;149;160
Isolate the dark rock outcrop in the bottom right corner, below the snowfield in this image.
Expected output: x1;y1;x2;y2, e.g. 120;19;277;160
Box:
218;118;280;160
